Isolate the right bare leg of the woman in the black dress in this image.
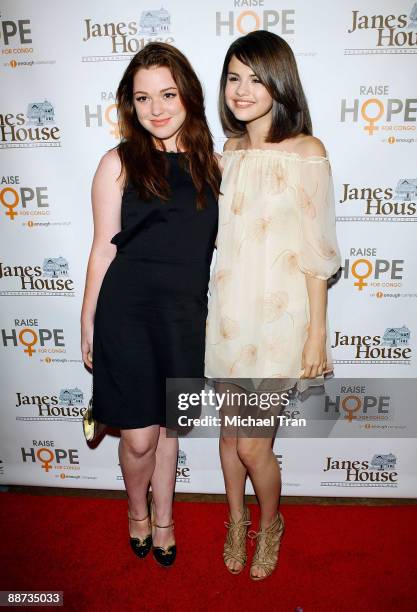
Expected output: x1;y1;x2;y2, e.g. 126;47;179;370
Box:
151;427;178;548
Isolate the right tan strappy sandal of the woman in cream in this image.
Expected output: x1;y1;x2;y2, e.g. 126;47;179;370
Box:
248;512;285;580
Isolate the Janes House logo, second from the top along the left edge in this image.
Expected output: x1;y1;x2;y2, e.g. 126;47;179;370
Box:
0;256;75;297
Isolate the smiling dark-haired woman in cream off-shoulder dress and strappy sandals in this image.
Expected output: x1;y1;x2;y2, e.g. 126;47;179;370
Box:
205;31;340;580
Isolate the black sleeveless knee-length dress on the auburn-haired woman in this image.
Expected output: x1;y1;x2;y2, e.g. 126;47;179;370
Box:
93;153;218;429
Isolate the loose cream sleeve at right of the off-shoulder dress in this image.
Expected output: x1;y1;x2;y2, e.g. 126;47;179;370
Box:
296;157;341;280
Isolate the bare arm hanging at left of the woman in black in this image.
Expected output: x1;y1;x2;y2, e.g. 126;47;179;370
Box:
81;149;122;368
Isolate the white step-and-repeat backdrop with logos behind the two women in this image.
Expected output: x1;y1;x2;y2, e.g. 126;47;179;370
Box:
0;0;417;497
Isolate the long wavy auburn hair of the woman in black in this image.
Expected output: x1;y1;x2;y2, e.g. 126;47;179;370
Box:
116;42;221;209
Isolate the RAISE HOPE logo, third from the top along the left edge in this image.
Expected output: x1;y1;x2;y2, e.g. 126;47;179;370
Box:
1;319;66;360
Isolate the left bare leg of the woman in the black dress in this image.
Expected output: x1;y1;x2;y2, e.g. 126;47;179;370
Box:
119;425;159;538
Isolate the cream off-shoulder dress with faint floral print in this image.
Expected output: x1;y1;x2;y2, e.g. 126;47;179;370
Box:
205;149;341;390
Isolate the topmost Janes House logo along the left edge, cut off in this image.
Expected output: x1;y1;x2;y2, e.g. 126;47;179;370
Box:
0;100;61;149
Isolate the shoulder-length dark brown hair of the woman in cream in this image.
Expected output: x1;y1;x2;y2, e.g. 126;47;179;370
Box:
219;30;312;142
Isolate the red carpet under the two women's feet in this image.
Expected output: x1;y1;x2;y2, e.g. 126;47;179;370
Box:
0;493;417;612
